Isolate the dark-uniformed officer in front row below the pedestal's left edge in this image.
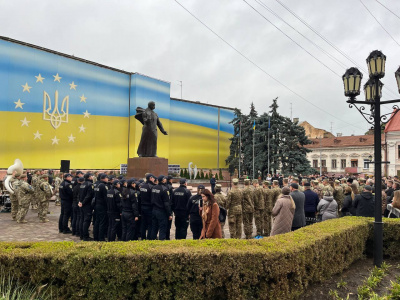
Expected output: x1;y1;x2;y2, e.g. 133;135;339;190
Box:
121;179;139;241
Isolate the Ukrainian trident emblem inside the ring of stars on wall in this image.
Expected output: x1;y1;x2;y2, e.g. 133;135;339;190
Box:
43;90;69;129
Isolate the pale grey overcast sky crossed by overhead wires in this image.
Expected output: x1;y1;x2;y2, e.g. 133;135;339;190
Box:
0;0;400;135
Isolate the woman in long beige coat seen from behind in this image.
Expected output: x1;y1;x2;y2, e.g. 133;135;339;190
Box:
271;187;296;236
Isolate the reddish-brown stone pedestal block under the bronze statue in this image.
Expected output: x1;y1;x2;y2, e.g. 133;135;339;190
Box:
127;157;168;179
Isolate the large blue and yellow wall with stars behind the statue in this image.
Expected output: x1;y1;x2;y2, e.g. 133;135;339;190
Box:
0;37;233;169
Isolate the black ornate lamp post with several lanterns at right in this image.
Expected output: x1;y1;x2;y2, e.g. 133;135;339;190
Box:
342;50;400;267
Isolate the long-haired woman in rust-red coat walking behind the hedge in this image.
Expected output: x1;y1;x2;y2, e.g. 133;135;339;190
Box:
200;190;222;239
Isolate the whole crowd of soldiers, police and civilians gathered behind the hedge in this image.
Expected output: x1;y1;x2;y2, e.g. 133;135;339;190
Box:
3;170;400;242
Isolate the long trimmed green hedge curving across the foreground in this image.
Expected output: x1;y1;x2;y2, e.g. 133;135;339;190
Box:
0;217;400;299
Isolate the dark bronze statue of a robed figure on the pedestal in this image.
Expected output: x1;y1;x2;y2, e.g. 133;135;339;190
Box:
135;101;168;157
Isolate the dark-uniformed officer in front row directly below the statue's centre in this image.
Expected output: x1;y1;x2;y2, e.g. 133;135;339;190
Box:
140;174;156;240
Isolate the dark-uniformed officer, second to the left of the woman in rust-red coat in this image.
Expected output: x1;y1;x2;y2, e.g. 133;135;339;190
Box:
172;178;192;240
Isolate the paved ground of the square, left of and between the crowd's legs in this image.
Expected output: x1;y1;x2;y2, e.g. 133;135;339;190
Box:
0;202;255;242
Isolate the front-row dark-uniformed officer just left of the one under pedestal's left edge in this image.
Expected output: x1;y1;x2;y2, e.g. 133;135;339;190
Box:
107;180;122;242
